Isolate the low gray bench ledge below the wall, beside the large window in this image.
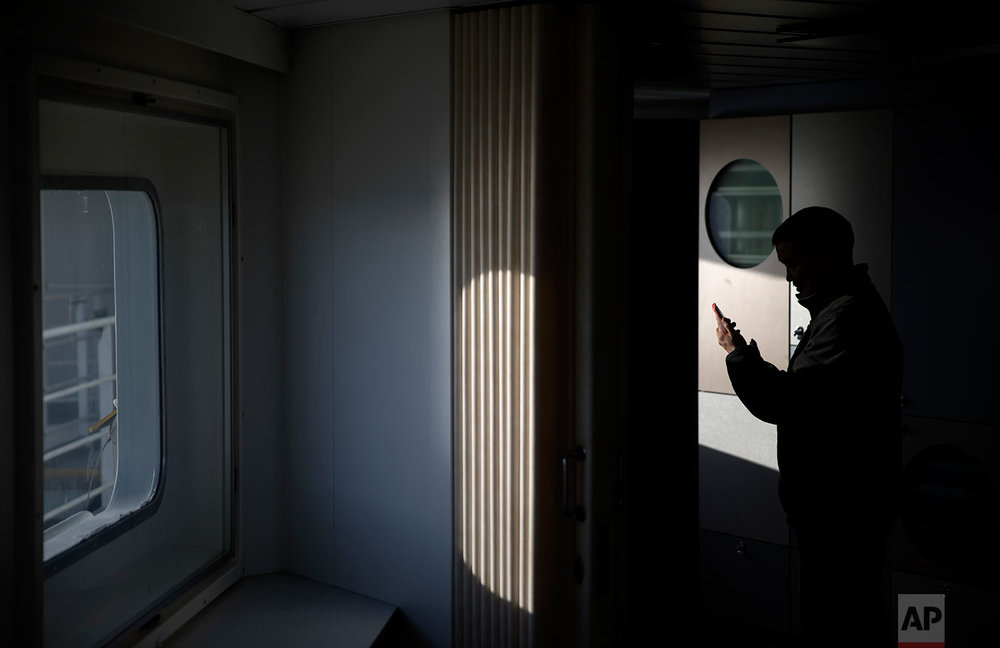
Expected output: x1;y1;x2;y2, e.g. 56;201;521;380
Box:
162;572;396;648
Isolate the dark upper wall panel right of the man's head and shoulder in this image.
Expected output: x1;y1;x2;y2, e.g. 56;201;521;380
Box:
892;101;1000;423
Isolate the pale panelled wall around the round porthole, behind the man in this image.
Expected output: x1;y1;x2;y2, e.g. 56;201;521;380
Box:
699;111;892;543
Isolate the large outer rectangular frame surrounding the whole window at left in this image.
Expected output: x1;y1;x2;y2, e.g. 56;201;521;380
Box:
9;57;243;644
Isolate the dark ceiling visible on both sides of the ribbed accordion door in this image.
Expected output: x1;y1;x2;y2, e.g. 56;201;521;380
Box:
222;0;1000;92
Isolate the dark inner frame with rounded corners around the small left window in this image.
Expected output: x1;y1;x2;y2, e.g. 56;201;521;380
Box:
37;175;167;578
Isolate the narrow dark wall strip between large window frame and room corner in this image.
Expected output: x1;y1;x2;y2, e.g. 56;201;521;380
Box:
230;63;285;574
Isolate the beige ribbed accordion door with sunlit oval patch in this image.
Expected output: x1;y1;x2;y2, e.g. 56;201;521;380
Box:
453;6;537;647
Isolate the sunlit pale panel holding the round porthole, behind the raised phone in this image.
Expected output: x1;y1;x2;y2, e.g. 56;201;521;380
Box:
697;116;791;545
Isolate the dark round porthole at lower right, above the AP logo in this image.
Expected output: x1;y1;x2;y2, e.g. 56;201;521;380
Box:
900;445;997;567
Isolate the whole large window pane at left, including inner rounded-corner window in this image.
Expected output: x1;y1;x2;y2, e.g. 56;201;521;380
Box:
37;90;239;648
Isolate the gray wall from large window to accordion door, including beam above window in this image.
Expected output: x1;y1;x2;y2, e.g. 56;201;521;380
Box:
6;3;451;644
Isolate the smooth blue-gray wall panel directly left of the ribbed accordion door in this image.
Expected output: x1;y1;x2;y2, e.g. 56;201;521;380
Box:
332;12;452;646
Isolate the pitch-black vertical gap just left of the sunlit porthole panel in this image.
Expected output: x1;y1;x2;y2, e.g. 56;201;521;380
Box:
618;120;698;646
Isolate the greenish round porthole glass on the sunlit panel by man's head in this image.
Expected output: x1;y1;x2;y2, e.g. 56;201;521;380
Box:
705;160;782;268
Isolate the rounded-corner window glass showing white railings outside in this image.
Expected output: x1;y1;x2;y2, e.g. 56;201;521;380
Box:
40;176;165;565
